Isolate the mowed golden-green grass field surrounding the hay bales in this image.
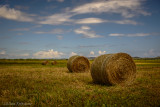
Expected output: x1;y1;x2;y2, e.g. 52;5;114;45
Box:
0;59;160;107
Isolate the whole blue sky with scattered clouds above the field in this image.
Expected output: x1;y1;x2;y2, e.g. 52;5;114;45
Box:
0;0;160;58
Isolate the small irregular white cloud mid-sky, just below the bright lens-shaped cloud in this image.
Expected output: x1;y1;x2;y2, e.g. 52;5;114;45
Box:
74;26;102;38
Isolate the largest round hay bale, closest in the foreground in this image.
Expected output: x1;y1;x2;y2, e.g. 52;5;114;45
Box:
91;53;136;85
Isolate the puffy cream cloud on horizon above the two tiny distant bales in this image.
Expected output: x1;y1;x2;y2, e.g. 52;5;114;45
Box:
33;49;64;58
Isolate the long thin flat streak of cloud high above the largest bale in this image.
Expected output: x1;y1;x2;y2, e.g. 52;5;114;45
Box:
109;33;152;37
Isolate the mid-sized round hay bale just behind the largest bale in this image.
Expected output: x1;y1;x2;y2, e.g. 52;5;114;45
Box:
67;55;90;72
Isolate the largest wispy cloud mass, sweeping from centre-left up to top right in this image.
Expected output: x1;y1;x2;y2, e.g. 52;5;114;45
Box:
39;0;150;25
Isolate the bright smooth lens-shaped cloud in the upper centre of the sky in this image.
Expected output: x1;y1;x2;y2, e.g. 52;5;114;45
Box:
75;18;107;24
